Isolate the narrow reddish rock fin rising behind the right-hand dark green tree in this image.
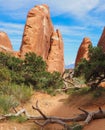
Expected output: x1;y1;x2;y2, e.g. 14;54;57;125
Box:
75;38;92;66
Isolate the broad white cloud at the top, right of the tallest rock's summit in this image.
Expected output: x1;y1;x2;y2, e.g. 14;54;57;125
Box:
51;0;99;17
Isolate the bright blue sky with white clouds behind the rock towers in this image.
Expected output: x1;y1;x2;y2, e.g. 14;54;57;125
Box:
0;0;105;65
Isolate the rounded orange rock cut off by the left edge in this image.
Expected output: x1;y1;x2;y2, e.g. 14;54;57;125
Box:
0;32;13;52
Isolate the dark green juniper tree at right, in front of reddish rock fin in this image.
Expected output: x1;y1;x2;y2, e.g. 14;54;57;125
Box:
75;46;105;89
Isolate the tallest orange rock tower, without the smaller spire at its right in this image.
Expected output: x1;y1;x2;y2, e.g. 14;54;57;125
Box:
20;5;54;59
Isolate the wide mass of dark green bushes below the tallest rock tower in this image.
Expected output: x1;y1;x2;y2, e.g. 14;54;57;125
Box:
0;53;63;95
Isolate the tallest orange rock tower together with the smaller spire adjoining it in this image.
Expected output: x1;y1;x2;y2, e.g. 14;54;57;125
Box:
20;5;64;73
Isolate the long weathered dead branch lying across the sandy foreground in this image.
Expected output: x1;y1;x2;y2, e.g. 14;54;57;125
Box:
0;101;105;130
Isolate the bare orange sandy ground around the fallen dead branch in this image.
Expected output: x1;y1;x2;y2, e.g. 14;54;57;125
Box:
0;92;105;130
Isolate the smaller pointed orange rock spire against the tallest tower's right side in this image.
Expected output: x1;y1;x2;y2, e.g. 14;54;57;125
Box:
47;30;64;73
